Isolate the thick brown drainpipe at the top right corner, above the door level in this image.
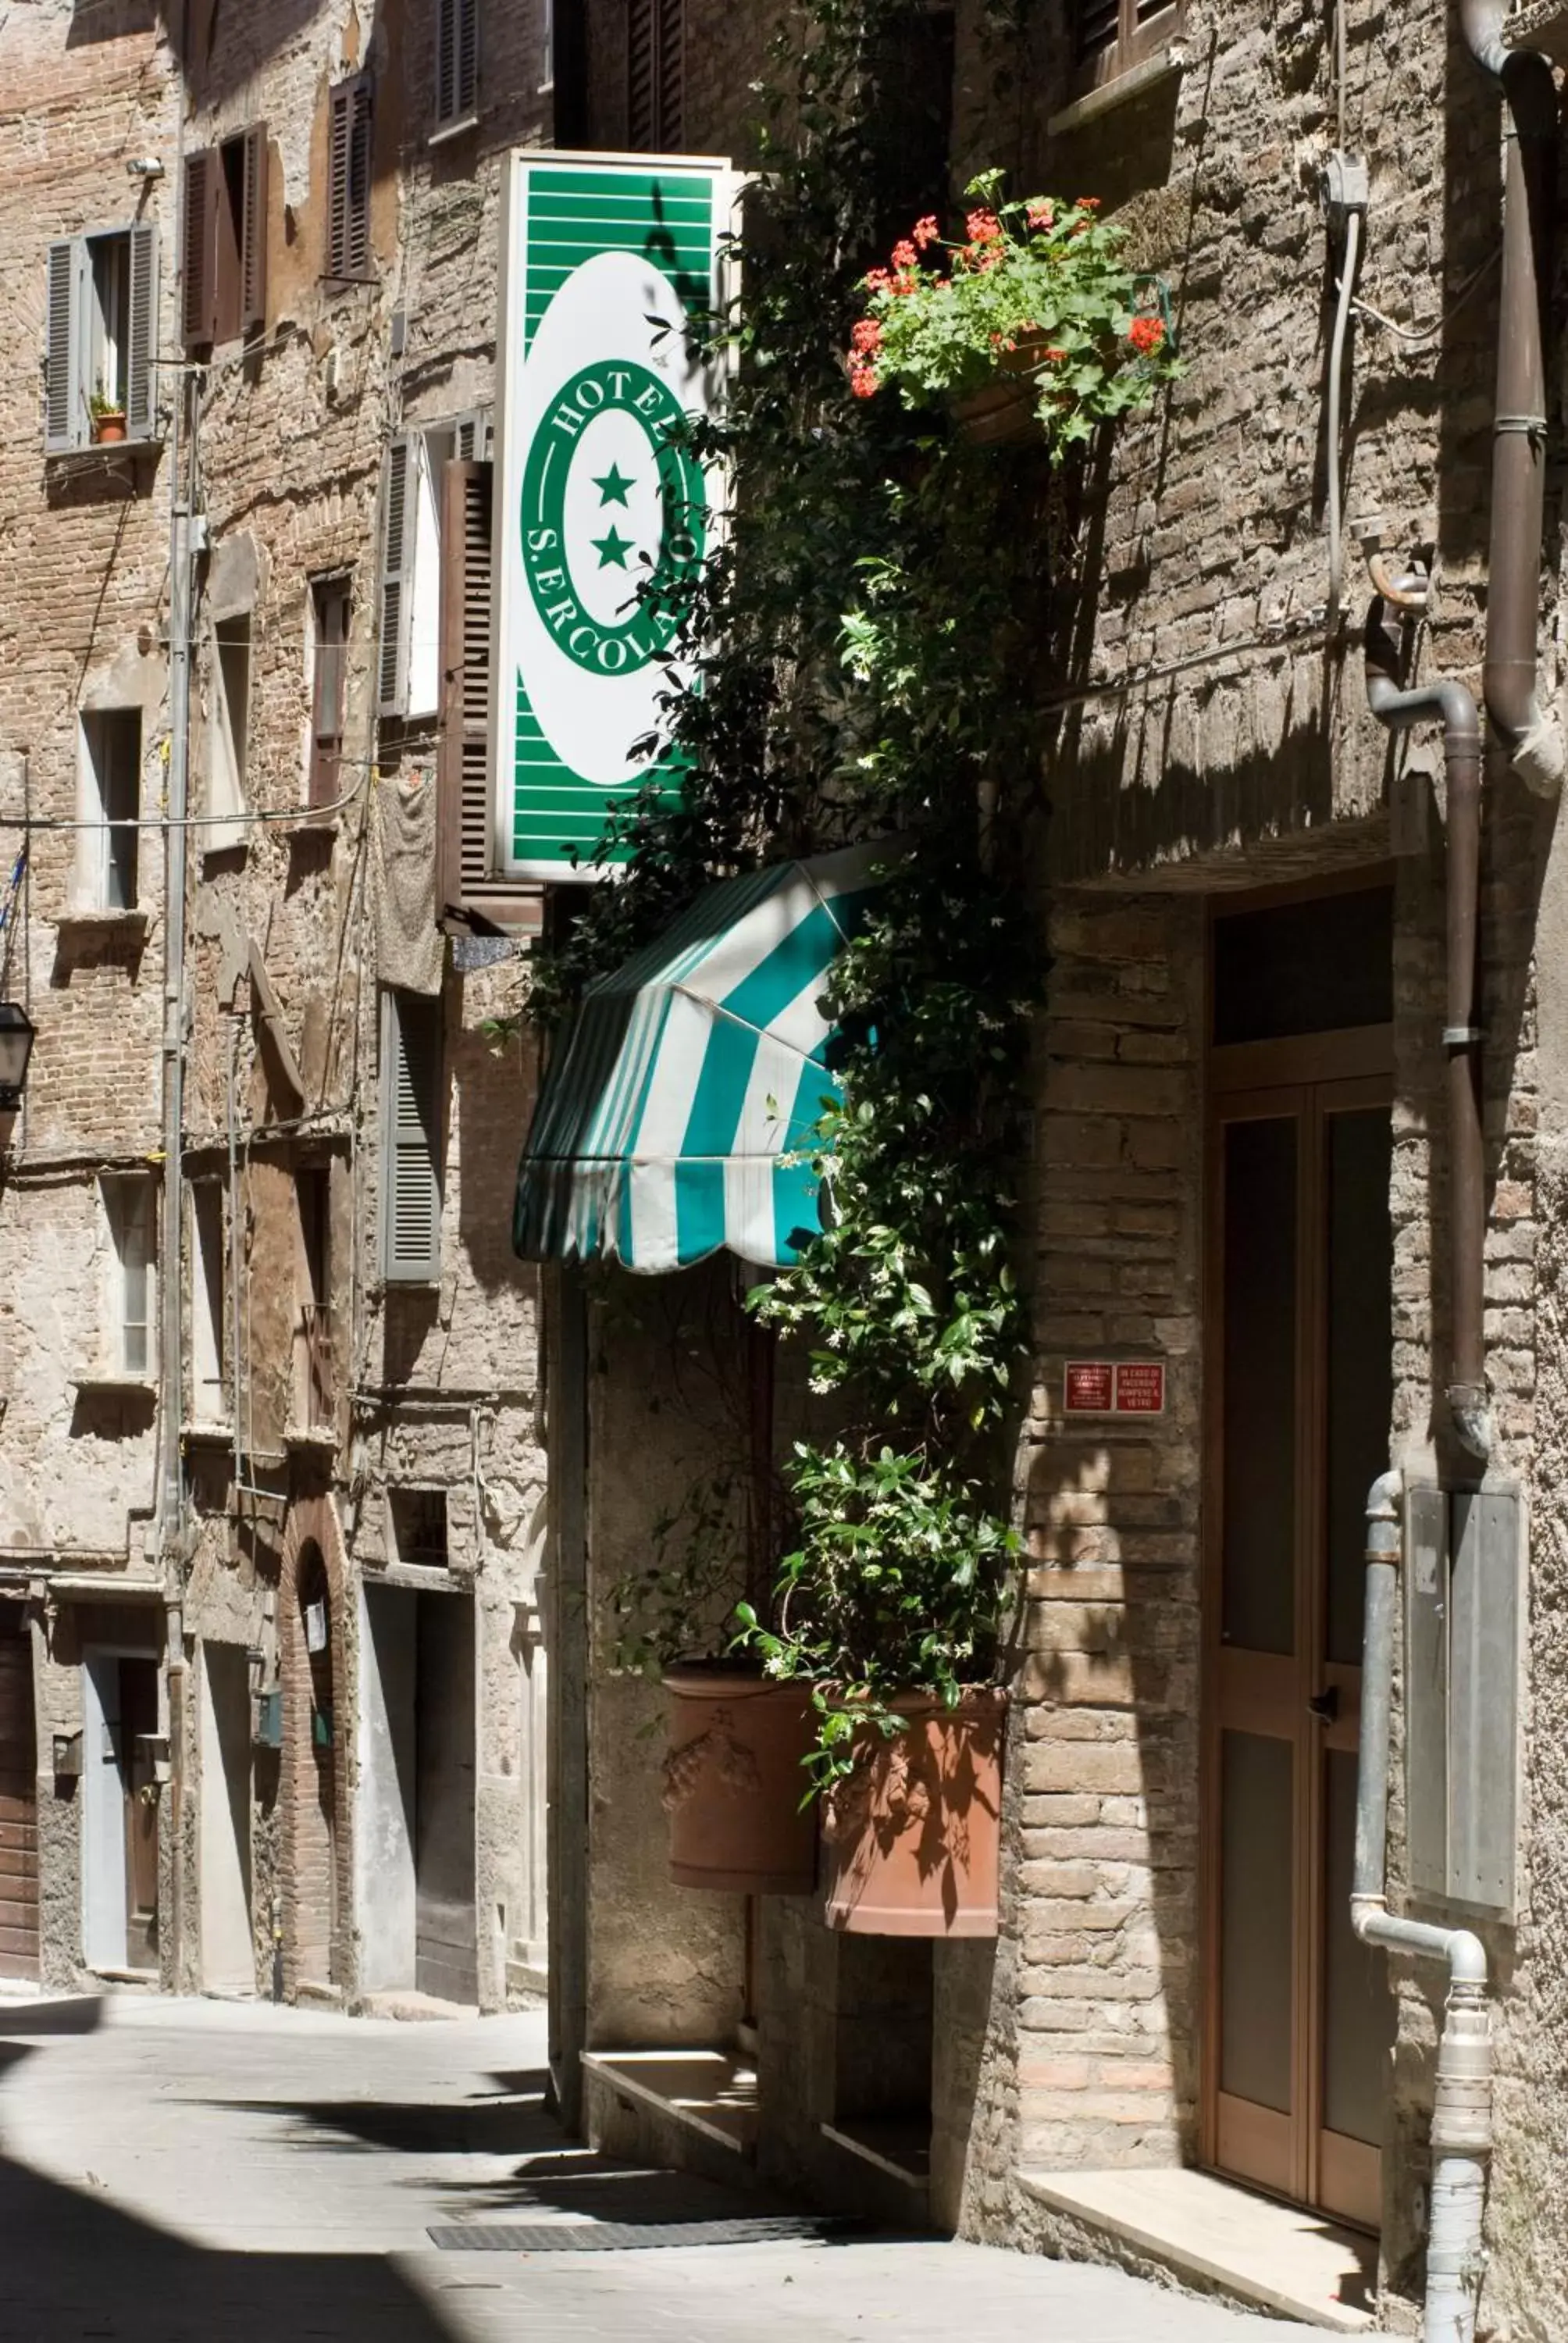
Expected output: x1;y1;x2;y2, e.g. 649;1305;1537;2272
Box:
1460;0;1563;797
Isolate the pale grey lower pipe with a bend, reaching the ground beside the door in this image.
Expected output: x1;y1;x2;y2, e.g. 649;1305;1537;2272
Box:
1350;1471;1491;2343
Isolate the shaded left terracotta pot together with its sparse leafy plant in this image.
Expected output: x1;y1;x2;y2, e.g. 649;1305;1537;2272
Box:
611;1471;816;1895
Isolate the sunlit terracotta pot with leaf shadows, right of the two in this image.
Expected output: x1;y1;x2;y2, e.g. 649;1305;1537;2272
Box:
823;1692;1006;1938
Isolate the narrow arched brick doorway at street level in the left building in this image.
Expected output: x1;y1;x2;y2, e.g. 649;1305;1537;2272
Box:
276;1497;351;2001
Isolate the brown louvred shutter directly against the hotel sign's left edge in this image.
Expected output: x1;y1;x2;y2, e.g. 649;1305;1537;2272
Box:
436;462;492;914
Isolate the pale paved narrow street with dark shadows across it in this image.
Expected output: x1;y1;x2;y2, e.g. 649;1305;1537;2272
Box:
0;1996;1306;2343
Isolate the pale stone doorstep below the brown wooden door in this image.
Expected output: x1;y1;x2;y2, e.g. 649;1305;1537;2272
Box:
1017;2167;1378;2334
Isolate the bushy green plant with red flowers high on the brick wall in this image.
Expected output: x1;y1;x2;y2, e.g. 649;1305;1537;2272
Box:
849;171;1181;455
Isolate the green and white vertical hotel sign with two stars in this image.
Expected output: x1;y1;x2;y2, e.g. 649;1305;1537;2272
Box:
494;152;738;879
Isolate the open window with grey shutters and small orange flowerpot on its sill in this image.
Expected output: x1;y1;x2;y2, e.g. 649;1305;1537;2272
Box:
45;223;157;455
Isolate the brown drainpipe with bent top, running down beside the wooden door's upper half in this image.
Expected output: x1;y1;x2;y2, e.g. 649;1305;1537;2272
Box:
1367;600;1493;1464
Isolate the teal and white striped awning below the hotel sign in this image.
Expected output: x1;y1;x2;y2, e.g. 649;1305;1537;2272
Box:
511;846;889;1270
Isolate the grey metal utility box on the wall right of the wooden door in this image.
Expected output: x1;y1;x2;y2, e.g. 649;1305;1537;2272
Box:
1404;1485;1523;1917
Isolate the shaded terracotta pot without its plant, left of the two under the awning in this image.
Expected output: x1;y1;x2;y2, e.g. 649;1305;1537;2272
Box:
663;1668;816;1895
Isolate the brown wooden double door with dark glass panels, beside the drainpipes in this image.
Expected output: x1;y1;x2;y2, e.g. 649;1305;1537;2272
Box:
1205;1054;1392;2228
